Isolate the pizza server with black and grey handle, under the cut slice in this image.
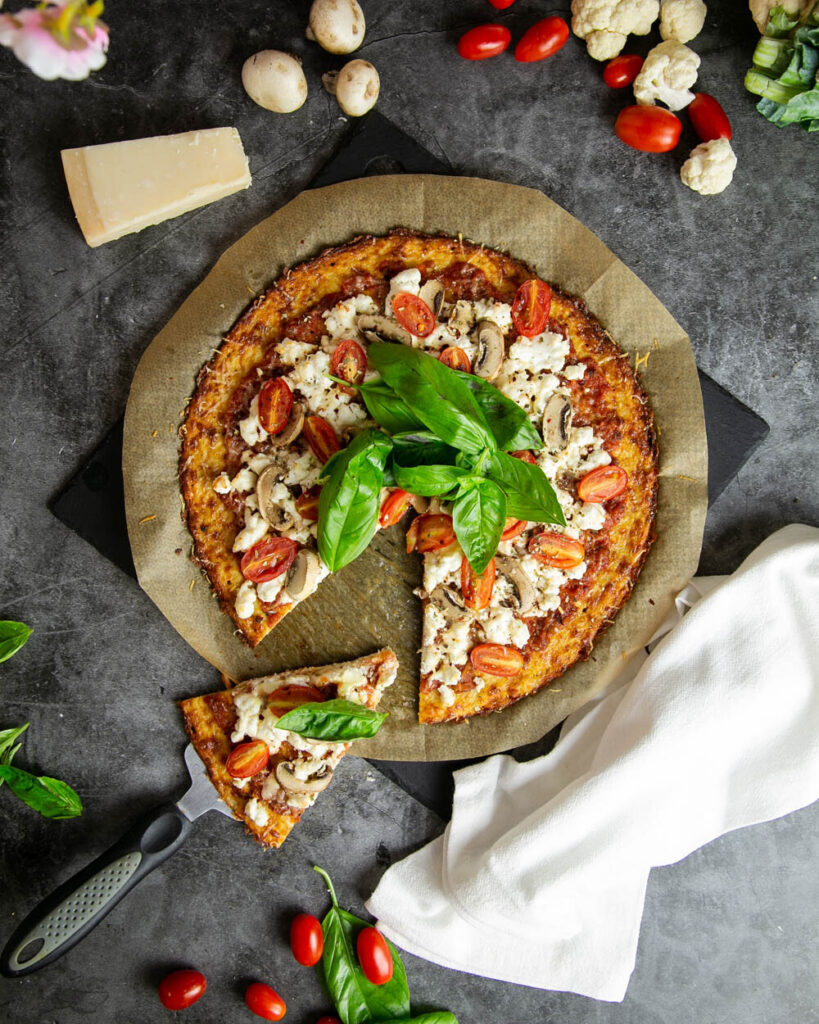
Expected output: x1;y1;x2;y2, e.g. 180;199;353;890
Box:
0;743;233;978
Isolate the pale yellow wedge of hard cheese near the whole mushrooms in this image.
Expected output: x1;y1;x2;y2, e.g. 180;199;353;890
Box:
62;128;251;246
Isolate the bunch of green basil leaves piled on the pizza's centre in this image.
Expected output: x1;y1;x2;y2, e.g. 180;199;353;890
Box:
318;342;566;574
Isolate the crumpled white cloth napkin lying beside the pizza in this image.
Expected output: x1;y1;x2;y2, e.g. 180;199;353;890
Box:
368;525;819;1001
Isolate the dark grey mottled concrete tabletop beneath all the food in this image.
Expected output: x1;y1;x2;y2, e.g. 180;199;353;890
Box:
0;0;819;1024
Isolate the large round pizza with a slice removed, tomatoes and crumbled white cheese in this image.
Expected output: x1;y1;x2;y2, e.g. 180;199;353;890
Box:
180;229;657;723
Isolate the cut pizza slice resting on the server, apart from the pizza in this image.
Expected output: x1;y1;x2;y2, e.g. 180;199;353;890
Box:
180;648;398;847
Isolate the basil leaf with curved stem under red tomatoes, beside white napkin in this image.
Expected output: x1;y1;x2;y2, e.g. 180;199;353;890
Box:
313;866;410;1024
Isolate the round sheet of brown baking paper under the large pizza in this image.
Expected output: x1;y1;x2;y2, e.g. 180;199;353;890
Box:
123;175;706;761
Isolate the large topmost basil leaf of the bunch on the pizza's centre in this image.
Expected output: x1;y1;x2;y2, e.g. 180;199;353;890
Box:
368;342;497;452
